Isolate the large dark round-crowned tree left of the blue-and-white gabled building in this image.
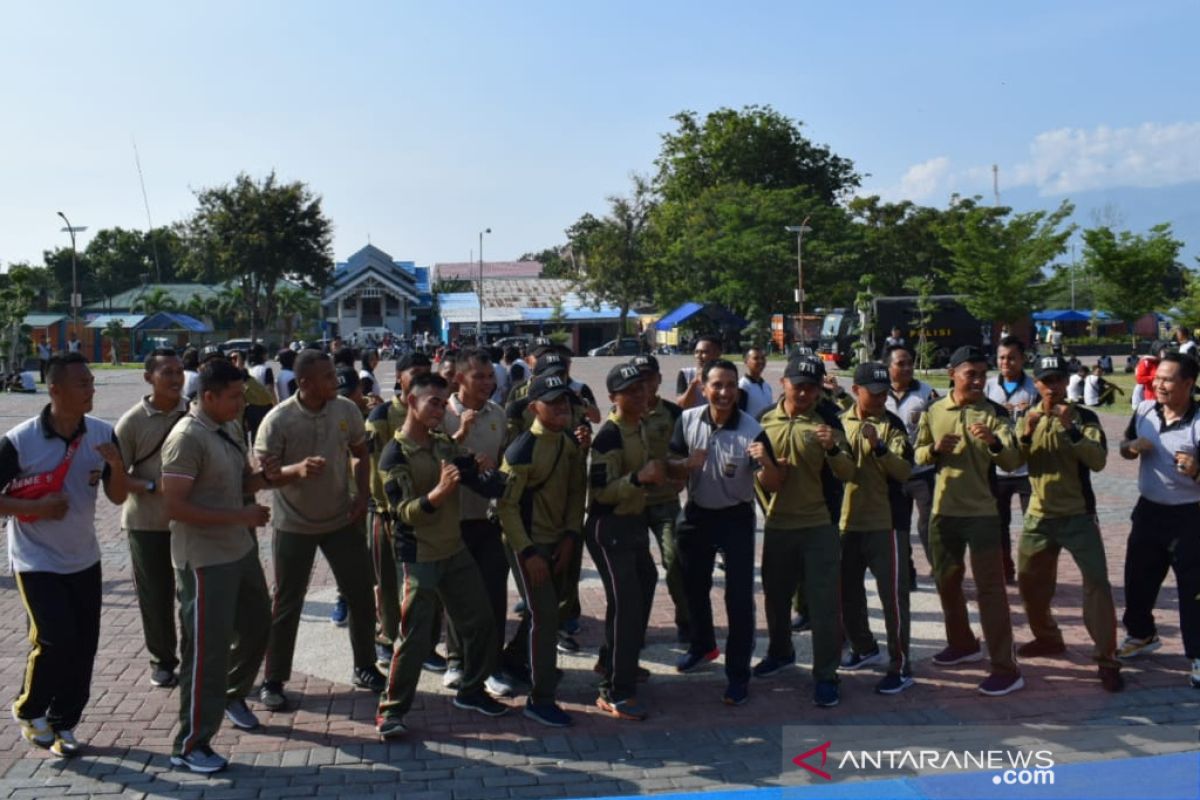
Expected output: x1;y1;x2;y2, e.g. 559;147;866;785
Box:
181;172;334;338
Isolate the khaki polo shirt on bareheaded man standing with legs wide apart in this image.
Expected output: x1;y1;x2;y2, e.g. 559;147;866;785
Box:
254;395;366;534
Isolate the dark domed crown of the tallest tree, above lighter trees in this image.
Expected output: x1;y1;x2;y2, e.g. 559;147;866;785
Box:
654;106;860;204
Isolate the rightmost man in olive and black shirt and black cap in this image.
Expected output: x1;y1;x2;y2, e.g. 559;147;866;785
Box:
1016;356;1124;692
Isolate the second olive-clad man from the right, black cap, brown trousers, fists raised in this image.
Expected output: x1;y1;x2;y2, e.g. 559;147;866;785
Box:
916;347;1025;697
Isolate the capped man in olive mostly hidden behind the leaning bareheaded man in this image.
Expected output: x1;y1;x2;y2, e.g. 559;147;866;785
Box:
366;353;440;669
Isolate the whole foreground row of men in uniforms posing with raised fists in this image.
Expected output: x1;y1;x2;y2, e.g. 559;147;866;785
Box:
0;331;1200;772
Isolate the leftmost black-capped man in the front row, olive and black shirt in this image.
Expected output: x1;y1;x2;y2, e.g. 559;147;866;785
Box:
497;374;586;727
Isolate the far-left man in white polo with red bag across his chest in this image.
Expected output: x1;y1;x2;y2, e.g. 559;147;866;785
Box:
0;353;128;757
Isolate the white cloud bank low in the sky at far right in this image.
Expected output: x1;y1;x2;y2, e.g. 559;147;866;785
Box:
866;122;1200;203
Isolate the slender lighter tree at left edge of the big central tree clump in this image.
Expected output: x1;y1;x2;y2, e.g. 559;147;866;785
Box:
568;175;654;335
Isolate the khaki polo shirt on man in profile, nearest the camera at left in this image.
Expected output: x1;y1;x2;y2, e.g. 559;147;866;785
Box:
162;408;256;570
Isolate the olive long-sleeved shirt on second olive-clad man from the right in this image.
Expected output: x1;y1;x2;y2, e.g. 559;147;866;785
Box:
916;391;1021;517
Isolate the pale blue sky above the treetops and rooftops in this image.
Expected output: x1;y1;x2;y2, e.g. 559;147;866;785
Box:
0;0;1200;272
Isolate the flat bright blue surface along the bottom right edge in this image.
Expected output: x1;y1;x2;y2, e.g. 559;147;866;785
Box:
576;752;1200;800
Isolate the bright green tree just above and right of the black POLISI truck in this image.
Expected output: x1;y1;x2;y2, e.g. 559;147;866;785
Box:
938;198;1075;323
